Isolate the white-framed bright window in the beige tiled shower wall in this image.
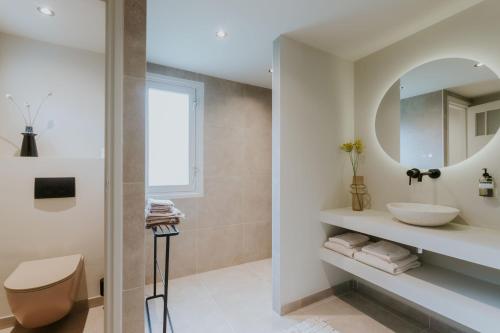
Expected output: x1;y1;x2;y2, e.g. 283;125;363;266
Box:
146;74;204;198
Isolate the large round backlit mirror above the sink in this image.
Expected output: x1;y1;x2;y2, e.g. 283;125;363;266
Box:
375;59;500;169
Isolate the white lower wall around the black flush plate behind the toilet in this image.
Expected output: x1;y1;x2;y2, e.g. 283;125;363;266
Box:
0;157;104;317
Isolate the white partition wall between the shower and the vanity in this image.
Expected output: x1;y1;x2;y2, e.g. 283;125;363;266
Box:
273;36;354;312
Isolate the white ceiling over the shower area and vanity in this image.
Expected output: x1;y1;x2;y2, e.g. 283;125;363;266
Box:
148;0;481;87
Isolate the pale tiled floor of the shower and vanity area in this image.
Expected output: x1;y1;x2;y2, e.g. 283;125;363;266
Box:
146;260;434;333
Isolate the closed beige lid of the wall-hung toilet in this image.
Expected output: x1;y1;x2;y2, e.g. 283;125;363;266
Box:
4;254;83;292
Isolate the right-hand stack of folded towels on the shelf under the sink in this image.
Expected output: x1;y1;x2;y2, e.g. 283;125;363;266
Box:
354;241;421;275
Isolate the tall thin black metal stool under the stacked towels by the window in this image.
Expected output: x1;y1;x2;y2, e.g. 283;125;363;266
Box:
146;225;179;333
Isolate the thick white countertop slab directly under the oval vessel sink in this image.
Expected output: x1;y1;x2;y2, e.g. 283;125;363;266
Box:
320;208;500;269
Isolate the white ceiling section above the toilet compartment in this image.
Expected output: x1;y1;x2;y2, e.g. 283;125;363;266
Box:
0;0;106;53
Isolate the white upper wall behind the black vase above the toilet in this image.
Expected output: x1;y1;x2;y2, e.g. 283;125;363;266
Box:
0;33;105;158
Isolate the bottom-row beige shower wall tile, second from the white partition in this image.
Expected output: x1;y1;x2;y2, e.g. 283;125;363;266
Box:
196;224;244;272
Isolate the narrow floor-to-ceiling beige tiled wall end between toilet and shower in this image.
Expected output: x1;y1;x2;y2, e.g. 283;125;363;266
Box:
122;0;147;326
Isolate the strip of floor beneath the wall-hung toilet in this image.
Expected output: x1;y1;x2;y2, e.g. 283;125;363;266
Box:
0;306;104;333
